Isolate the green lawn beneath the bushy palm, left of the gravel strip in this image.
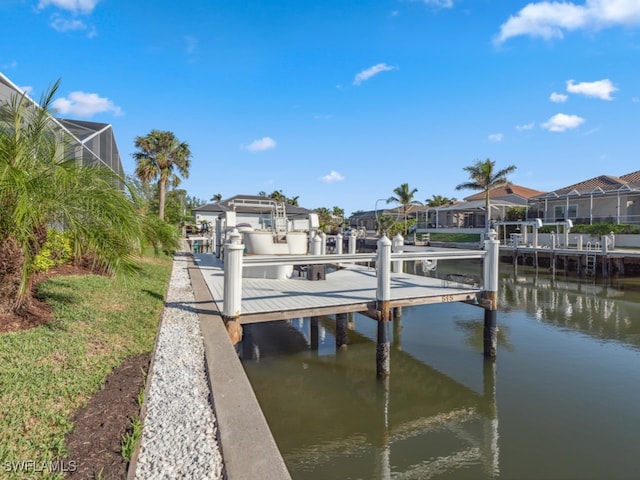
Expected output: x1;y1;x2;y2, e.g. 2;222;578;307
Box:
0;258;171;479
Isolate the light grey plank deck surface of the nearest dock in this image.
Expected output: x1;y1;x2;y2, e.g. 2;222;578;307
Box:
195;252;483;323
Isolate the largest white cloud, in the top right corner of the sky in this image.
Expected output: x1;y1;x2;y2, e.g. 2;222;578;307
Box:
495;0;640;43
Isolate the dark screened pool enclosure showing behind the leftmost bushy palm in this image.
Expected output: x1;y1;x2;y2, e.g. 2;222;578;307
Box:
0;73;124;185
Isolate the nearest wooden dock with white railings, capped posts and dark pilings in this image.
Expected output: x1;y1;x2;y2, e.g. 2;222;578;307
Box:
195;235;499;378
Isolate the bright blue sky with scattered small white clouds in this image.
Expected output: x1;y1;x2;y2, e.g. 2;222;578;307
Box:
0;0;640;214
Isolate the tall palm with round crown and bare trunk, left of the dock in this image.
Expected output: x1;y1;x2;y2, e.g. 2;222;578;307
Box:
133;130;191;220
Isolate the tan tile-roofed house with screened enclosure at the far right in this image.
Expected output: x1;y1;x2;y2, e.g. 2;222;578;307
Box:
529;170;640;224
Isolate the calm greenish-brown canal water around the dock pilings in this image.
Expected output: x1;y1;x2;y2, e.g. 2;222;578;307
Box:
241;265;640;480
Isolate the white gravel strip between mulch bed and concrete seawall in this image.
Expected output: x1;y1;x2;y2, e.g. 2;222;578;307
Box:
135;254;224;480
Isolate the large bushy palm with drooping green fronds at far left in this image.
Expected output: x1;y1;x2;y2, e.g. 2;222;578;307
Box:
0;81;142;314
